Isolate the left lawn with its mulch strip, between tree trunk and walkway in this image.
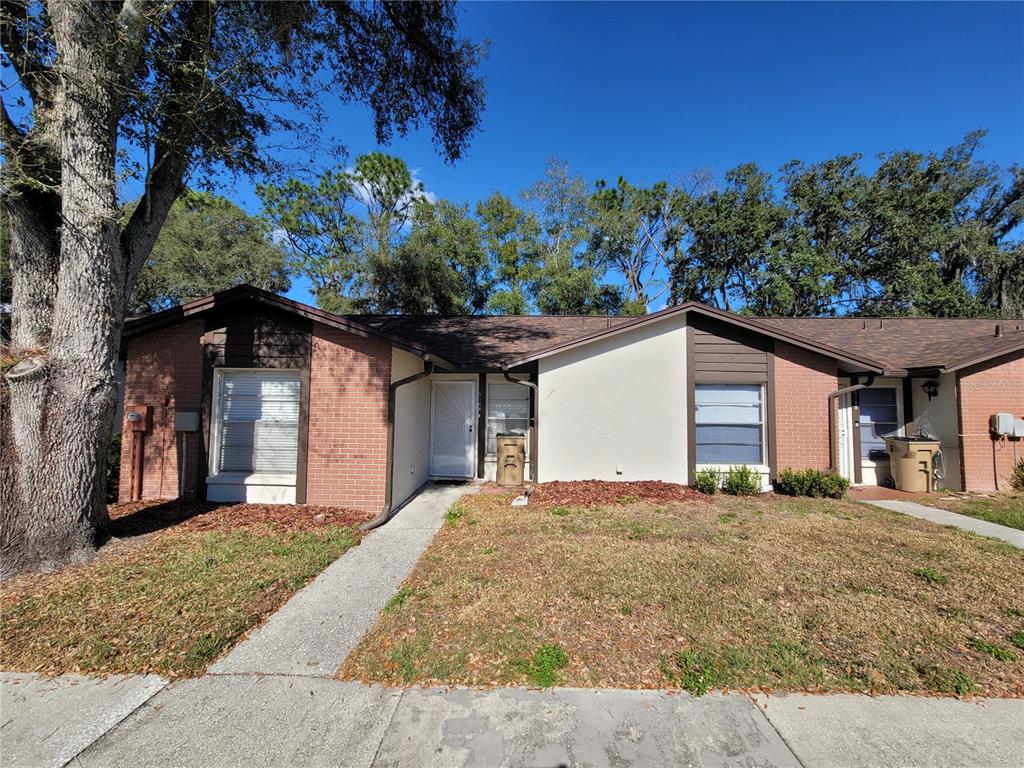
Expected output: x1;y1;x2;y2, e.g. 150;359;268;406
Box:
0;503;366;677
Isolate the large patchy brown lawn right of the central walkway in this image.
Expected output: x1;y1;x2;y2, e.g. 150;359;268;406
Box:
339;494;1024;695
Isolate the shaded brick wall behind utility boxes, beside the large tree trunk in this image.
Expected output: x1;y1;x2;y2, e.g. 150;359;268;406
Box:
118;318;204;501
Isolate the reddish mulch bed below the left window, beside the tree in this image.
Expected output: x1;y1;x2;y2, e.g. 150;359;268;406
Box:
108;500;373;539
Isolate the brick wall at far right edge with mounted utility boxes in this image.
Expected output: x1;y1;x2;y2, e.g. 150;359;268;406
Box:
956;352;1024;490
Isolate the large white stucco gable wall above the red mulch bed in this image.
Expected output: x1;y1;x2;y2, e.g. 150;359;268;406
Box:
538;316;687;483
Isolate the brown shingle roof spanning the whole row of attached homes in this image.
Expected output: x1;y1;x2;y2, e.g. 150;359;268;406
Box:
125;286;1024;373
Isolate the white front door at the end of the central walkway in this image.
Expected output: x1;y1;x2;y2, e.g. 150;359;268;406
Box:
430;380;476;477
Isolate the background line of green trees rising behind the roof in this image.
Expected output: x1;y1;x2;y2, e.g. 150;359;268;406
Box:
130;132;1024;316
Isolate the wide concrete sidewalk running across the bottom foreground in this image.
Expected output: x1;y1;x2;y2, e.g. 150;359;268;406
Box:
0;675;1024;768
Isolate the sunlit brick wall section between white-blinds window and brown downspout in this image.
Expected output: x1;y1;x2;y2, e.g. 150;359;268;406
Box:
306;323;391;512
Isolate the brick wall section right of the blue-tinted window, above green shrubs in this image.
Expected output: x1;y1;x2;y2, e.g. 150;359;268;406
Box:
774;342;839;470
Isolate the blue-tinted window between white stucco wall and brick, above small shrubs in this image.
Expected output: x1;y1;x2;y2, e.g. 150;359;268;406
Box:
694;384;764;464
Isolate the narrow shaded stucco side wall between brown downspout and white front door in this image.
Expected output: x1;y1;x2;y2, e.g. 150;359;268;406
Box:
391;347;430;505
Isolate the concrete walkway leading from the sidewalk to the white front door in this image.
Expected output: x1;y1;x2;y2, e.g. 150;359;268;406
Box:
209;483;476;677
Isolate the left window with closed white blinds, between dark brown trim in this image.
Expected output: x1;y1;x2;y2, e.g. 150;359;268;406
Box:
216;371;299;474
